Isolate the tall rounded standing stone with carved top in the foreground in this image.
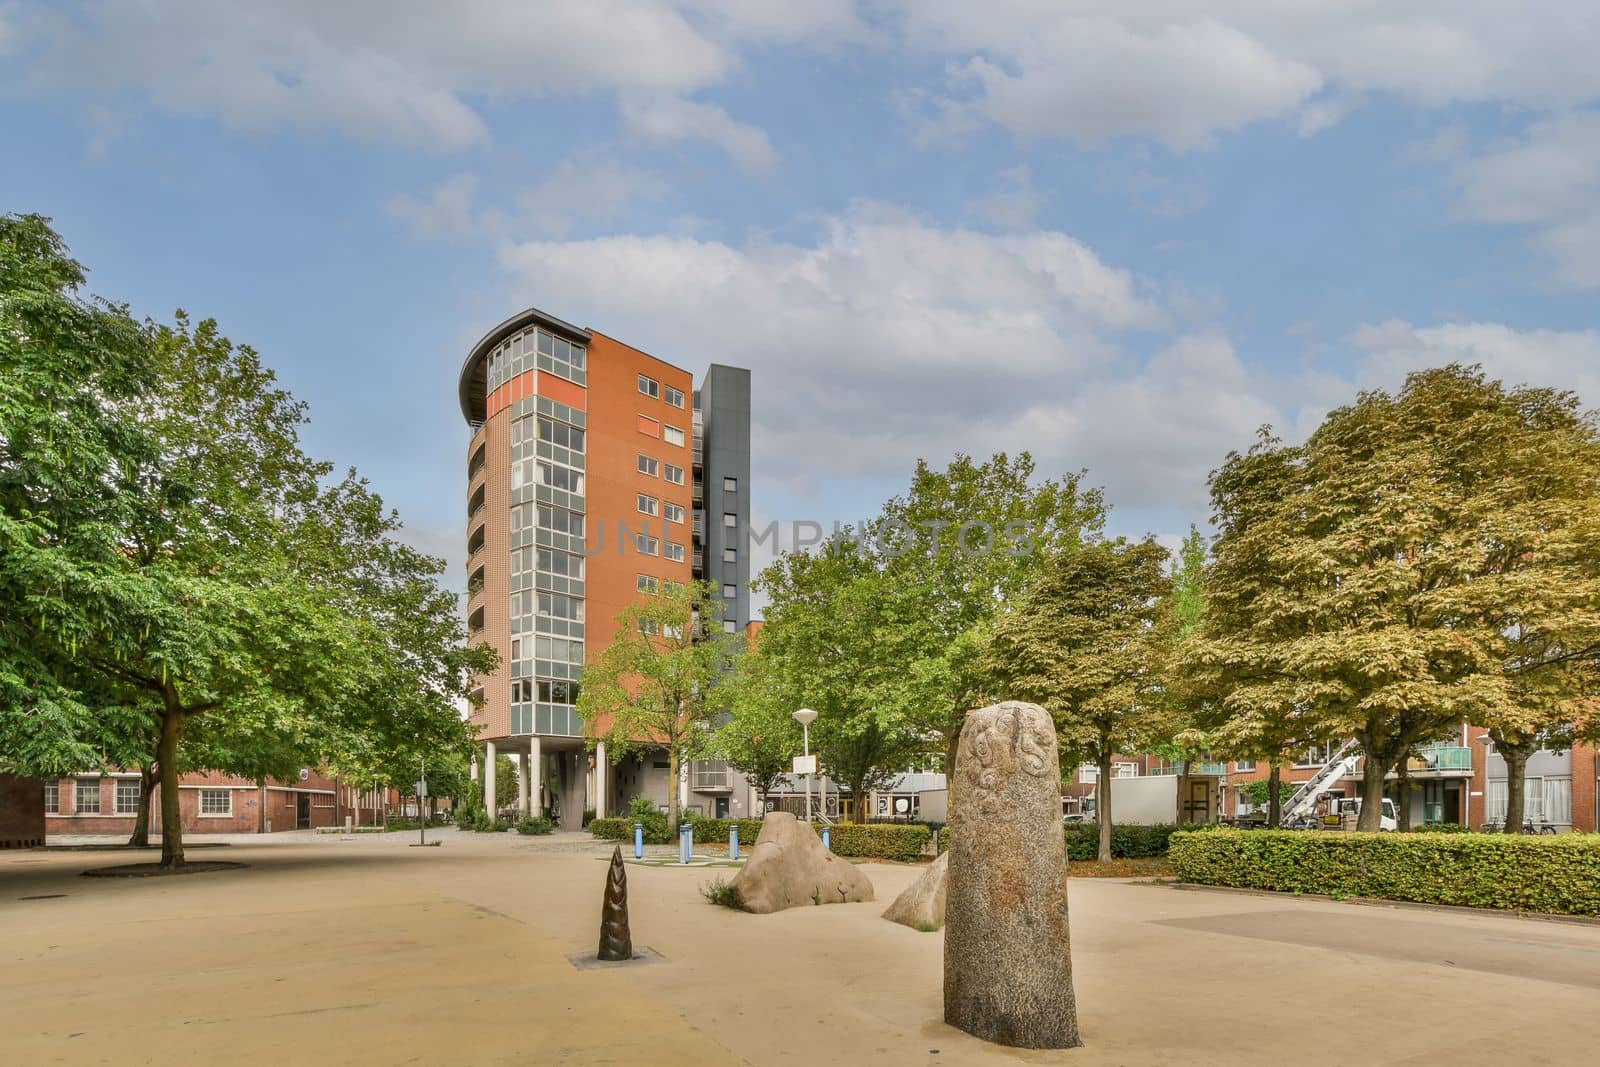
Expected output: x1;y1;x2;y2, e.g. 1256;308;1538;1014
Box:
944;701;1082;1048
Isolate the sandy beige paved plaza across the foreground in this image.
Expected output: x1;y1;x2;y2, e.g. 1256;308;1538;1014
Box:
0;830;1600;1067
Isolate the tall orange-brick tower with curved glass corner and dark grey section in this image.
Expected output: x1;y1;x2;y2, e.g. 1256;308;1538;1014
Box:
459;309;750;829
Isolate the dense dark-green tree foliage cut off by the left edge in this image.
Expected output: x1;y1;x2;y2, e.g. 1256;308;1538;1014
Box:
0;214;155;776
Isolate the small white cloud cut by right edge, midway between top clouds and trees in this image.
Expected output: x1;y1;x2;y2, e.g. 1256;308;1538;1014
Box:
1453;110;1600;286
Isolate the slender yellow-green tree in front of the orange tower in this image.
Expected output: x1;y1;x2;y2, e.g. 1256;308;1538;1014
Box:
578;582;723;825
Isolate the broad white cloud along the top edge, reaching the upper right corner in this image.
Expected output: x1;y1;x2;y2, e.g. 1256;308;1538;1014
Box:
891;0;1600;149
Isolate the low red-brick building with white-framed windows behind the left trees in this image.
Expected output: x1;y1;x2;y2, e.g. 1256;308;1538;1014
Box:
35;771;394;837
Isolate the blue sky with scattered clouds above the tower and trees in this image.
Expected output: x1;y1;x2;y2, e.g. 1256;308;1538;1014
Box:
0;0;1600;598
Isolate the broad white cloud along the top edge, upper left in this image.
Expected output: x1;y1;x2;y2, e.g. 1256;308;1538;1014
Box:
16;0;738;150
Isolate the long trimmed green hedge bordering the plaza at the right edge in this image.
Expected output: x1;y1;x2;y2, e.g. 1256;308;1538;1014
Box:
1168;830;1600;915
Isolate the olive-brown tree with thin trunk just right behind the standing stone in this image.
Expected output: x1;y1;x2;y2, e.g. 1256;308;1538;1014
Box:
984;537;1173;862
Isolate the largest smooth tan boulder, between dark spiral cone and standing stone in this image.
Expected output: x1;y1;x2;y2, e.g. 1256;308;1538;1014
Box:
733;811;872;915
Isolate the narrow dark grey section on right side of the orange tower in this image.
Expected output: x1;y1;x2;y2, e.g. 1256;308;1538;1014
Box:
694;363;750;632
